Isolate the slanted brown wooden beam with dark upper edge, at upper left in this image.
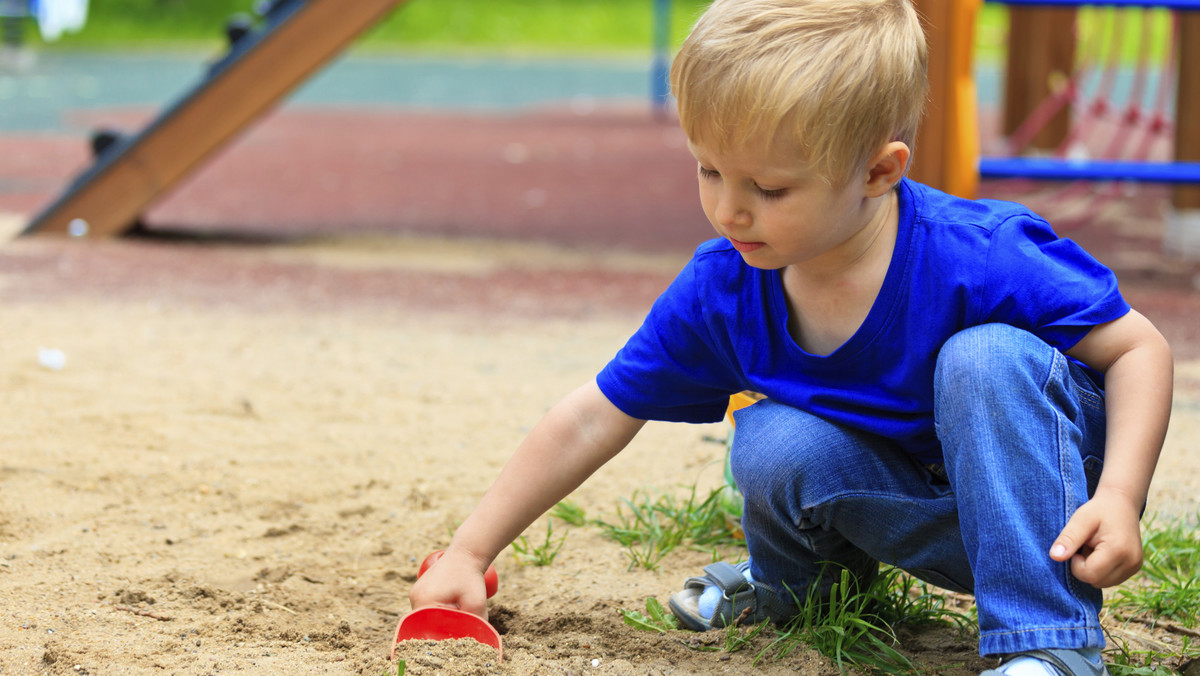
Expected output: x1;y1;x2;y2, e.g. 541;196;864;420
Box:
25;0;402;237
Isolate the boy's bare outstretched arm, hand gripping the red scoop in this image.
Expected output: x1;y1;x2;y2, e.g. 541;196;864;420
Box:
409;382;646;618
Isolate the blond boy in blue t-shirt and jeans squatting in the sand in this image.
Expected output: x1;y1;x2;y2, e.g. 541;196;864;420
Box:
410;0;1171;676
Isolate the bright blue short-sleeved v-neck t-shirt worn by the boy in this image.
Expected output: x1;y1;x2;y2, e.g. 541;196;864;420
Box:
596;180;1129;462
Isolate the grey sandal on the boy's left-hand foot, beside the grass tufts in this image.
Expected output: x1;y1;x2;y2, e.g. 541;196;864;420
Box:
668;561;800;632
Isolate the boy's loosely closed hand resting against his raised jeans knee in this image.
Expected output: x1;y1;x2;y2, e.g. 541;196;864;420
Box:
1050;491;1142;588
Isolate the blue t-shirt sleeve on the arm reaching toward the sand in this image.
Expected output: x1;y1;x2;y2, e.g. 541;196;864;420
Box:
596;259;744;423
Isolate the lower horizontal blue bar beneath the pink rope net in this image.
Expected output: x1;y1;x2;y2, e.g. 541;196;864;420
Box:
979;157;1200;184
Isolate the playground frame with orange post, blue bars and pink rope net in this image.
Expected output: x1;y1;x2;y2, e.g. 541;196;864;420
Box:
913;0;1200;200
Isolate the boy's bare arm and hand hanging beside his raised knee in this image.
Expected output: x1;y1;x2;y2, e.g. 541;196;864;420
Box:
1050;310;1174;587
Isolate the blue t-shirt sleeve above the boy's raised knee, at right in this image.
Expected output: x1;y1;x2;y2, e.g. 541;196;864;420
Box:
980;216;1129;351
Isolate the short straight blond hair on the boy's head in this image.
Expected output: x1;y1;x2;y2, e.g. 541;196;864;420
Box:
671;0;929;183
